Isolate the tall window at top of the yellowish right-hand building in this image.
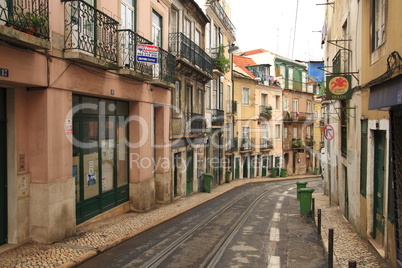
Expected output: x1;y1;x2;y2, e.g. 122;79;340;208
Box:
372;0;386;51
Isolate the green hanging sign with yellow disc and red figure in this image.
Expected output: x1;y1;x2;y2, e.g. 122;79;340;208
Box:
326;75;353;100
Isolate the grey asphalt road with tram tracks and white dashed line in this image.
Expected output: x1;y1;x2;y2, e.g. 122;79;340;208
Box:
79;179;327;268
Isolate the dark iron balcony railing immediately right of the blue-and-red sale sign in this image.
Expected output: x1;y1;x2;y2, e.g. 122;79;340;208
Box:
153;48;176;83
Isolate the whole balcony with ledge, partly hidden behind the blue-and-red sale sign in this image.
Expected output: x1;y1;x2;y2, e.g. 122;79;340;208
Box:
118;30;153;80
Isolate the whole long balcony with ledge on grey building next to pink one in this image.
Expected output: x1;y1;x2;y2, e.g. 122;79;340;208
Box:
169;33;213;81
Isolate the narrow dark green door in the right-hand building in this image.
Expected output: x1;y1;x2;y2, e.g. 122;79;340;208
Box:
373;131;385;239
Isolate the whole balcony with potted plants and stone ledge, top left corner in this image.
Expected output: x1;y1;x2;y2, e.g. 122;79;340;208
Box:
0;0;51;49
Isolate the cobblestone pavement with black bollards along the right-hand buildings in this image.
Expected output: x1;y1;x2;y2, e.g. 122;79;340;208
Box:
313;193;391;268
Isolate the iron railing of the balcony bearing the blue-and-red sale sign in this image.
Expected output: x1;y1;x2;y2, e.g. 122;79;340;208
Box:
117;29;152;76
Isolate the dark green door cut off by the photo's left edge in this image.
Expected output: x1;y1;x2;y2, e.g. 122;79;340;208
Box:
0;89;7;245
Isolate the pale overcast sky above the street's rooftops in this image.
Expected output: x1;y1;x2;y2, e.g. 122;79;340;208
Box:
226;0;326;61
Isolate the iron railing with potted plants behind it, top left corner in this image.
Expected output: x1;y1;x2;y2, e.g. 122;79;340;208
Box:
0;0;49;39
